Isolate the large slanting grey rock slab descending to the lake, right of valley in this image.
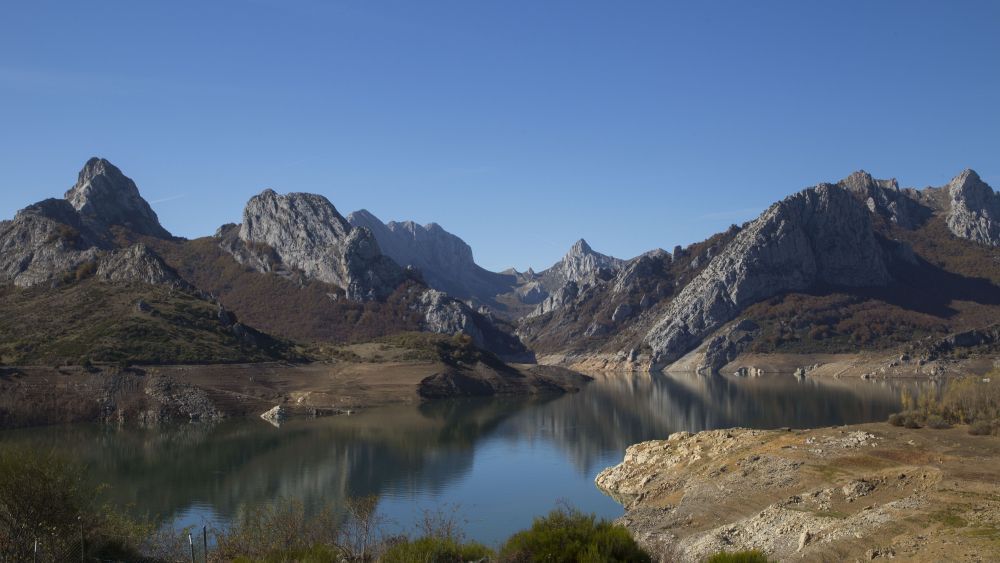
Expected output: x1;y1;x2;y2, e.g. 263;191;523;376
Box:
645;184;889;368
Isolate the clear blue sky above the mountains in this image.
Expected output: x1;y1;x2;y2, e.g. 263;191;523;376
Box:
0;0;1000;269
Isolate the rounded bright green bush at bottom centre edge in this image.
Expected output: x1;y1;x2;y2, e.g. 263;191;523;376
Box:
500;508;651;563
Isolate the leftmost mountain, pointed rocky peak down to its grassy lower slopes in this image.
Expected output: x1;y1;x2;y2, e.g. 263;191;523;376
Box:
0;158;295;364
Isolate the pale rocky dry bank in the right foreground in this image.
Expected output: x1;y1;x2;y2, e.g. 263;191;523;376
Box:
597;423;1000;562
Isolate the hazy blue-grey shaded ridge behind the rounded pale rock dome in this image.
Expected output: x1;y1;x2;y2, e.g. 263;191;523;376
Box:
347;209;516;302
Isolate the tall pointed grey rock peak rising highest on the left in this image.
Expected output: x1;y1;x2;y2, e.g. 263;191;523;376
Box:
65;157;170;238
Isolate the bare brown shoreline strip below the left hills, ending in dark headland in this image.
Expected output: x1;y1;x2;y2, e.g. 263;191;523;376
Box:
0;359;590;428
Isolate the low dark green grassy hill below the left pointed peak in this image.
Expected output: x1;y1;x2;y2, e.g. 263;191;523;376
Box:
0;279;294;365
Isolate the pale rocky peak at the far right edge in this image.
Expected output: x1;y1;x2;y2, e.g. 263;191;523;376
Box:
946;170;1000;246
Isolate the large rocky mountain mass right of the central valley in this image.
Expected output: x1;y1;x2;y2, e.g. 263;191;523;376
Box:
518;170;1000;369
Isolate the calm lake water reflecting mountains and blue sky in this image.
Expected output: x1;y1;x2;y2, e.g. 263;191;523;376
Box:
0;374;914;544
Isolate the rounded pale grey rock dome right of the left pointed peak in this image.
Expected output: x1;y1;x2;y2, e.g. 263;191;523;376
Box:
234;190;406;301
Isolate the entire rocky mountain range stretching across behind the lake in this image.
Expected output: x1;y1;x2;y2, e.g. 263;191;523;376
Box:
0;158;1000;371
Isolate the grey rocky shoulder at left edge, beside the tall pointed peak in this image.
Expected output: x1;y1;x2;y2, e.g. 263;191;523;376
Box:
0;199;99;287
